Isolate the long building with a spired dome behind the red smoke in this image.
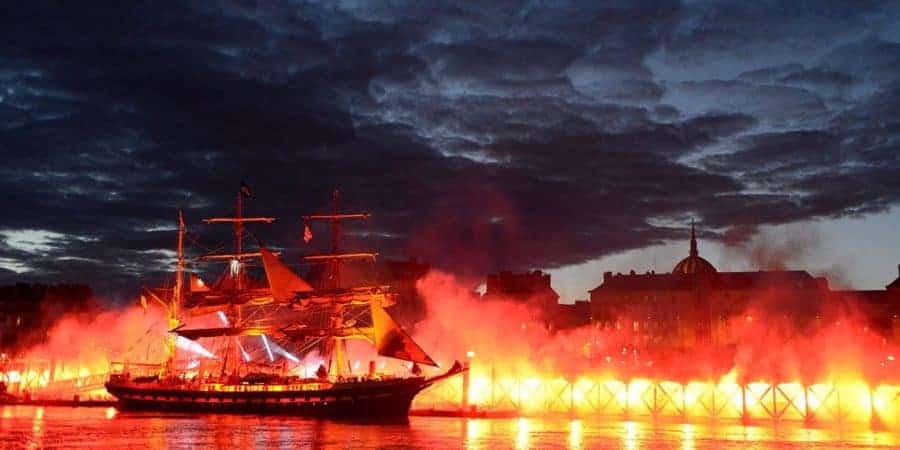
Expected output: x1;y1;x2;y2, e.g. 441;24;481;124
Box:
590;225;900;349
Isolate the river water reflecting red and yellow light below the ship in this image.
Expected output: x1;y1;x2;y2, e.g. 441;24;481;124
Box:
0;406;900;450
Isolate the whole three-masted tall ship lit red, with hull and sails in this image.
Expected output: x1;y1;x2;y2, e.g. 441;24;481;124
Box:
106;183;467;419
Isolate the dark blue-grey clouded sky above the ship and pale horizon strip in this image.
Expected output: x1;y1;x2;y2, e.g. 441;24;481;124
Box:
0;0;900;297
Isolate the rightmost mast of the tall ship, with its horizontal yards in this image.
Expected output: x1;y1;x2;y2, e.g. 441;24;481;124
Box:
303;188;378;377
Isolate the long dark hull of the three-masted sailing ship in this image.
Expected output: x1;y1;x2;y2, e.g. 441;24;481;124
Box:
106;378;431;419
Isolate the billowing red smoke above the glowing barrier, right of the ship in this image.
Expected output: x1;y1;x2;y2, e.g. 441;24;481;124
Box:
415;271;900;382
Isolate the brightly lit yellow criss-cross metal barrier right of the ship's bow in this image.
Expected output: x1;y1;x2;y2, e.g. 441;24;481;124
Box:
413;362;900;429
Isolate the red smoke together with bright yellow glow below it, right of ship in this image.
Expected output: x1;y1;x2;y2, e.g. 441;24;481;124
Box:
413;272;900;430
